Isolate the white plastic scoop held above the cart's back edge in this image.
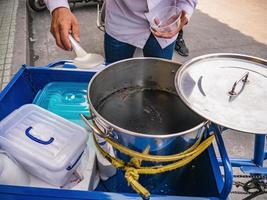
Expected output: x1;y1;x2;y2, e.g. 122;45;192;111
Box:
69;35;104;68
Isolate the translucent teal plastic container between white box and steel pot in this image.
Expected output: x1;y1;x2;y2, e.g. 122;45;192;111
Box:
33;82;89;125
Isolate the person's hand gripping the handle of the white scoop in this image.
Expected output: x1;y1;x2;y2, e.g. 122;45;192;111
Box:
50;7;80;50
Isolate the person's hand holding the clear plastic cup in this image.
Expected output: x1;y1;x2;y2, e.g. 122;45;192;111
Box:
151;11;188;39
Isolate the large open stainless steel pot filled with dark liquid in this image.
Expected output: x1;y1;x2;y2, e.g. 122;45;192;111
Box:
84;58;206;157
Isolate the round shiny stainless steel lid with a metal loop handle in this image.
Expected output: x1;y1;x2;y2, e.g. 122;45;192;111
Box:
175;54;267;134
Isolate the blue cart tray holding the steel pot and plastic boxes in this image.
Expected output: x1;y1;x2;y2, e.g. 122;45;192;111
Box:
0;63;231;200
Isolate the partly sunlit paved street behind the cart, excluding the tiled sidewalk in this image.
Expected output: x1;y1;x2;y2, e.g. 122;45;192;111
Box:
27;0;267;65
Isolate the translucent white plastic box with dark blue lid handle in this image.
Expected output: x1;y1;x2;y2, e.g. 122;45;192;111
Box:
0;104;88;186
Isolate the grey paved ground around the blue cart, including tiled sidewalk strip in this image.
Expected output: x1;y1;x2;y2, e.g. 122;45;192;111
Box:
0;0;267;199
